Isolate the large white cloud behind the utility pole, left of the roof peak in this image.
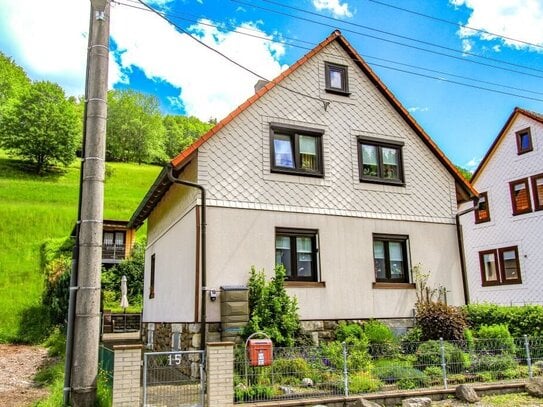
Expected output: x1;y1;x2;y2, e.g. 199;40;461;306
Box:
0;0;286;120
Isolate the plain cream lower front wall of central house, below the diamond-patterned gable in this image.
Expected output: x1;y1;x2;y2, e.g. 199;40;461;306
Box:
202;207;464;321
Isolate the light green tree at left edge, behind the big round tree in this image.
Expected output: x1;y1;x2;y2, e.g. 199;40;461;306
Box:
0;52;30;119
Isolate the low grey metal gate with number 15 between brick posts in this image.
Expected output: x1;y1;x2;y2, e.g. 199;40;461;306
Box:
143;351;205;407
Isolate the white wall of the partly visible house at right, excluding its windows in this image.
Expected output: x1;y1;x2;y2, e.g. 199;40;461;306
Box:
461;115;543;305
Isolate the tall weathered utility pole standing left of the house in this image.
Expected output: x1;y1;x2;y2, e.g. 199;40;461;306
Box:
67;0;109;407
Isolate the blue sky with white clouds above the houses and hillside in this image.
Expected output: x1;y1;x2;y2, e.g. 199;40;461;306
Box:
0;0;543;169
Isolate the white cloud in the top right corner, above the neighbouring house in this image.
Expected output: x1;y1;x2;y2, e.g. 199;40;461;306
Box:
449;0;543;52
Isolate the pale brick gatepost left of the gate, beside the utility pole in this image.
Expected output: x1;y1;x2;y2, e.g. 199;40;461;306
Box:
112;345;143;407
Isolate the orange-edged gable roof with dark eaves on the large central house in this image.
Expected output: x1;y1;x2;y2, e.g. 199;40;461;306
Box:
130;30;478;230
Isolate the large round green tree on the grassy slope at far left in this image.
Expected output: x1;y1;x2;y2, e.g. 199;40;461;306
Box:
0;81;81;174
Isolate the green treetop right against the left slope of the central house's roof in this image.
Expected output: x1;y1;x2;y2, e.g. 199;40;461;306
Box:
163;115;214;158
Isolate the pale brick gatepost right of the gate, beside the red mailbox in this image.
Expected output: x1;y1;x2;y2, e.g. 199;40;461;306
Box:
206;342;234;407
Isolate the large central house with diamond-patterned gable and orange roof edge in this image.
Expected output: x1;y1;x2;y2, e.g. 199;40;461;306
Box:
129;31;476;344
